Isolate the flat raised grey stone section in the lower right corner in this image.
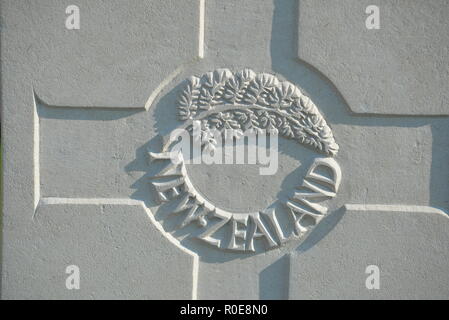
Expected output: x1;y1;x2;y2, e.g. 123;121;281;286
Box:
289;205;449;299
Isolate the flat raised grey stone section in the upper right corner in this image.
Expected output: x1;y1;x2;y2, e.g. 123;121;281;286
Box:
298;0;449;115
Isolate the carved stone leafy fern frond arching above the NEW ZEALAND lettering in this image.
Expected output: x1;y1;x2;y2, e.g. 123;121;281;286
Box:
178;69;339;156
